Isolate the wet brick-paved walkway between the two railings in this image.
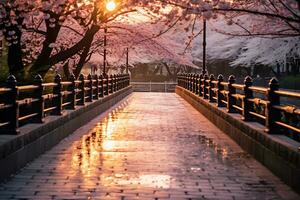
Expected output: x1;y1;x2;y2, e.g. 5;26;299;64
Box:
0;93;300;200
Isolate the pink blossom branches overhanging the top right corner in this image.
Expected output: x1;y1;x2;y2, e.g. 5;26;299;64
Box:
158;0;300;37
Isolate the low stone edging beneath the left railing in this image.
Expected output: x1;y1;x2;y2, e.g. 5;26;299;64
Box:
0;86;132;181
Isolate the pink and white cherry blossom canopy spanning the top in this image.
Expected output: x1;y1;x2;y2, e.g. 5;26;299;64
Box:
0;0;300;79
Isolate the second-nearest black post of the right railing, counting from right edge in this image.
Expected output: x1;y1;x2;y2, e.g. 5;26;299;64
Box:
242;76;253;121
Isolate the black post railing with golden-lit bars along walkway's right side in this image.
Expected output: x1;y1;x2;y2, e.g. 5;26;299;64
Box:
178;74;300;141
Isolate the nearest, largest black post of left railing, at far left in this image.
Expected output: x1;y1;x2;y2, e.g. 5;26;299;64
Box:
6;75;20;134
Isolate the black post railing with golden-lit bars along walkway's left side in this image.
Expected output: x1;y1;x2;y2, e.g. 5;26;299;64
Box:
0;74;130;134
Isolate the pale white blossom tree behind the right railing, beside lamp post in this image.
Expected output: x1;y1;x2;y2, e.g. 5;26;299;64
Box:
193;19;300;74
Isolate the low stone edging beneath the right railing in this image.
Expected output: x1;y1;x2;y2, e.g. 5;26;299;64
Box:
176;86;300;193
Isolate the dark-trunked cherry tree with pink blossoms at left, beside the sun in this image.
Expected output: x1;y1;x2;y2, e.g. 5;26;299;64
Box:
0;0;168;79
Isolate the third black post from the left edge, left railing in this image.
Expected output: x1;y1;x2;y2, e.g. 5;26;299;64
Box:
53;74;63;115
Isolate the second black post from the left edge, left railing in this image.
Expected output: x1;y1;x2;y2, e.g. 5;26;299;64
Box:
32;74;44;123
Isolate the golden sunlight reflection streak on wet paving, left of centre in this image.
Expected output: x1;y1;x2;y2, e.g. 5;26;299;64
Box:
65;101;171;188
